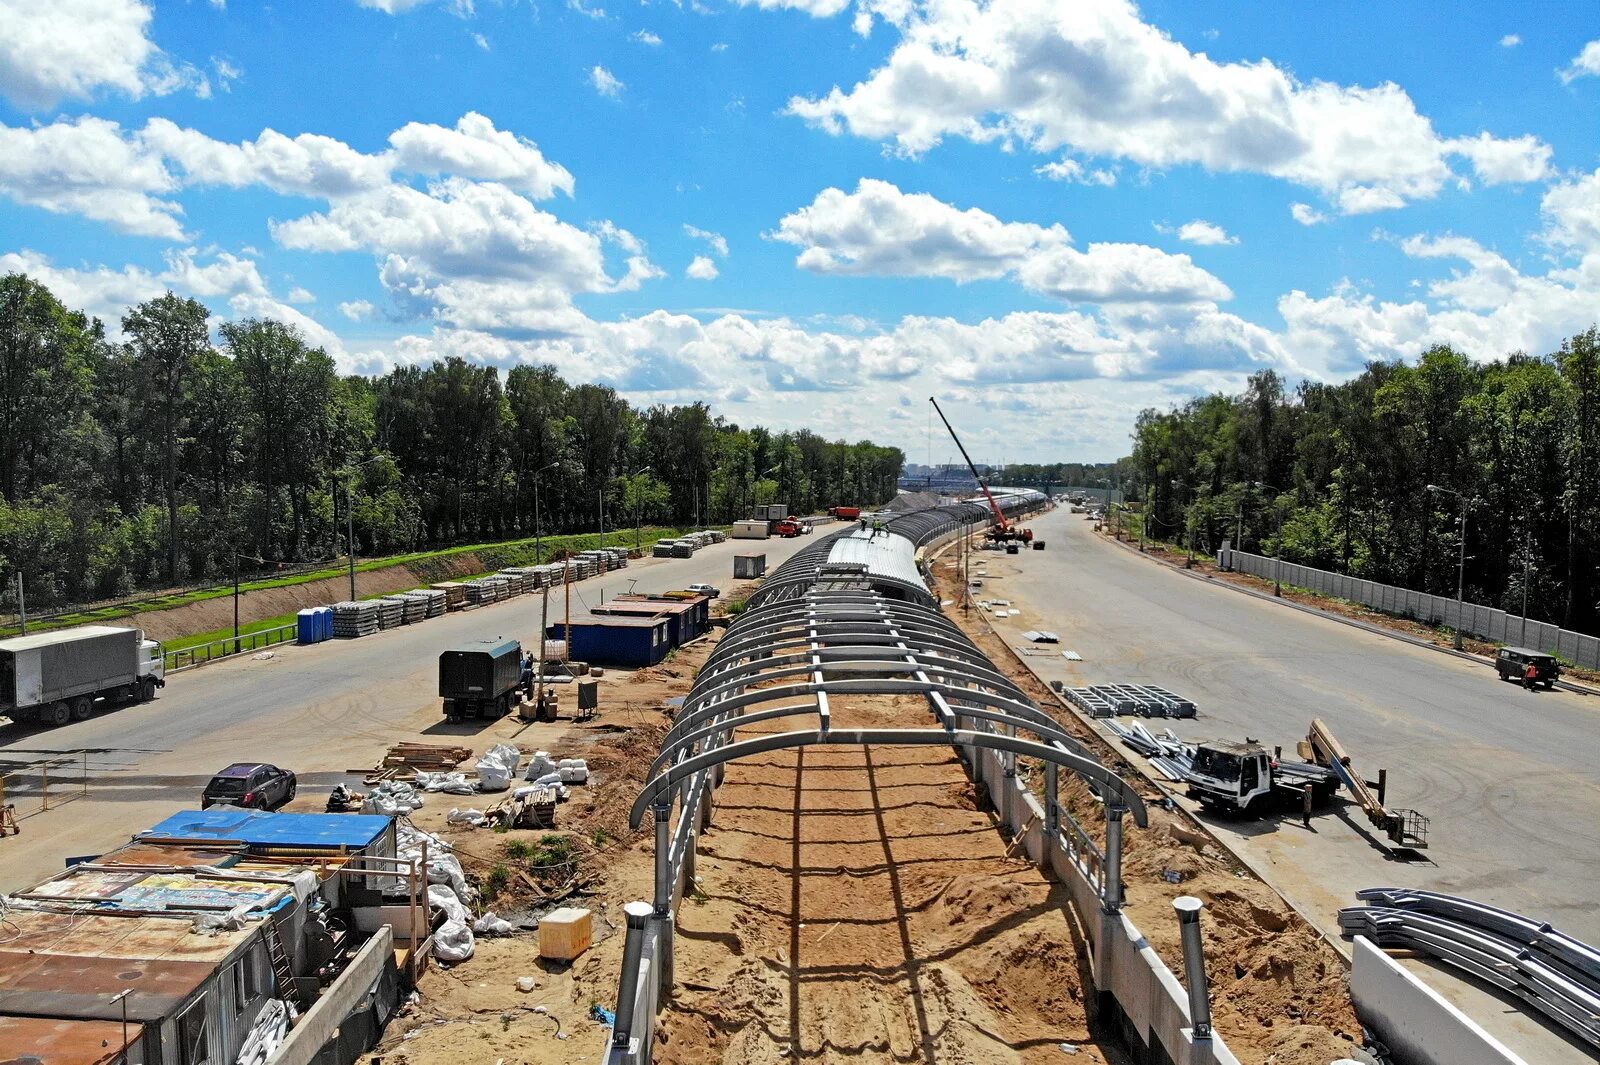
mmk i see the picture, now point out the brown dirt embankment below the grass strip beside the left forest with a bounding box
[132,552,488,640]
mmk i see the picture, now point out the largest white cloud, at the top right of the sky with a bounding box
[789,0,1555,214]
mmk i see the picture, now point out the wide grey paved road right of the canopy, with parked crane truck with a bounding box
[974,507,1600,1062]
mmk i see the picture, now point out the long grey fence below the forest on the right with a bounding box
[1218,547,1600,670]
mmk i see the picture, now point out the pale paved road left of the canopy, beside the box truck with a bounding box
[0,526,806,892]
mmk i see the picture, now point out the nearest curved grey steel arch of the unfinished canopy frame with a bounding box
[627,729,1149,828]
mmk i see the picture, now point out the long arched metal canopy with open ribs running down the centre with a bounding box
[608,493,1147,1065]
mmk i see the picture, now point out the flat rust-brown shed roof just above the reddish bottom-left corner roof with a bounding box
[0,943,216,1023]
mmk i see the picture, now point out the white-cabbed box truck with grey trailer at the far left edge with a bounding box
[0,625,166,724]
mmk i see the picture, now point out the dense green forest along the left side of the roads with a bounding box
[0,273,904,608]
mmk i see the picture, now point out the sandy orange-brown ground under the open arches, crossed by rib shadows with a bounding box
[656,687,1125,1065]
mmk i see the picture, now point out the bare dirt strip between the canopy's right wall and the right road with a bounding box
[934,546,1362,1065]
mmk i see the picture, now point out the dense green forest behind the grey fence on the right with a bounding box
[1133,328,1600,632]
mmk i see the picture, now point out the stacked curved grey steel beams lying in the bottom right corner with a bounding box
[1339,888,1600,1047]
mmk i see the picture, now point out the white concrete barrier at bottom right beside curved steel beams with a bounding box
[1350,935,1528,1065]
